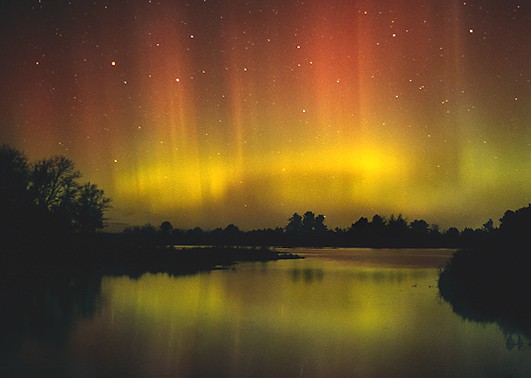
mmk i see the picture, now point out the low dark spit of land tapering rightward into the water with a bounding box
[0,235,302,277]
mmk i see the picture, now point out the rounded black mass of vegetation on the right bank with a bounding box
[439,205,531,338]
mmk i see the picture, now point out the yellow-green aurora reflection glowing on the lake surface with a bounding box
[79,260,529,377]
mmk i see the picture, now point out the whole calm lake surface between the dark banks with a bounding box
[0,249,531,377]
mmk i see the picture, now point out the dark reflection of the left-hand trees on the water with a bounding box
[0,273,101,376]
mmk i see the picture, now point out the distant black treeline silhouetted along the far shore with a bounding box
[123,211,510,248]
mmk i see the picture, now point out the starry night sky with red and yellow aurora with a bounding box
[0,0,531,230]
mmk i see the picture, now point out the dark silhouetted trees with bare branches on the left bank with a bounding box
[0,145,110,244]
